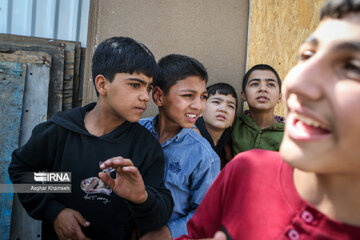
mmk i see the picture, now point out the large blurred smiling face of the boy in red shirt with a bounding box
[280,14,360,174]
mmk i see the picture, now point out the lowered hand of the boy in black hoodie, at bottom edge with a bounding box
[54,208,90,240]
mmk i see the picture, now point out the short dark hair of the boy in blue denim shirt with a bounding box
[154,54,208,94]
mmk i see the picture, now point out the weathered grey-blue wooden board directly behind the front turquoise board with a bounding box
[0,51,51,240]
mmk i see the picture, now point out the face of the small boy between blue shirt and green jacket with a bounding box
[203,93,236,130]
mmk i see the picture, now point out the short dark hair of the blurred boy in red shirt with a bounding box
[320,0,360,20]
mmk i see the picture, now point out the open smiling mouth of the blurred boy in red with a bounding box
[286,113,331,140]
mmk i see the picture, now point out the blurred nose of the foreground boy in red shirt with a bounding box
[283,56,331,101]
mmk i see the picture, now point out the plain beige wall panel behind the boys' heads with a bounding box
[83,0,249,116]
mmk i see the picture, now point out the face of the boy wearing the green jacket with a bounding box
[241,70,281,111]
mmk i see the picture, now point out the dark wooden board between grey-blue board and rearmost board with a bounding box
[0,40,64,118]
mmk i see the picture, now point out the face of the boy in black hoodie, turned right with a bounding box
[100,73,152,122]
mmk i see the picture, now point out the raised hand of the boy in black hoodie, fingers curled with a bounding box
[99,157,148,204]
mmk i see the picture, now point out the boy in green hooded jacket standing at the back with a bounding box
[231,64,284,155]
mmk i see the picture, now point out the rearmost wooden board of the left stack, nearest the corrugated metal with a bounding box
[0,34,81,110]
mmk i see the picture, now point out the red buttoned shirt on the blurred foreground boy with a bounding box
[178,149,360,240]
